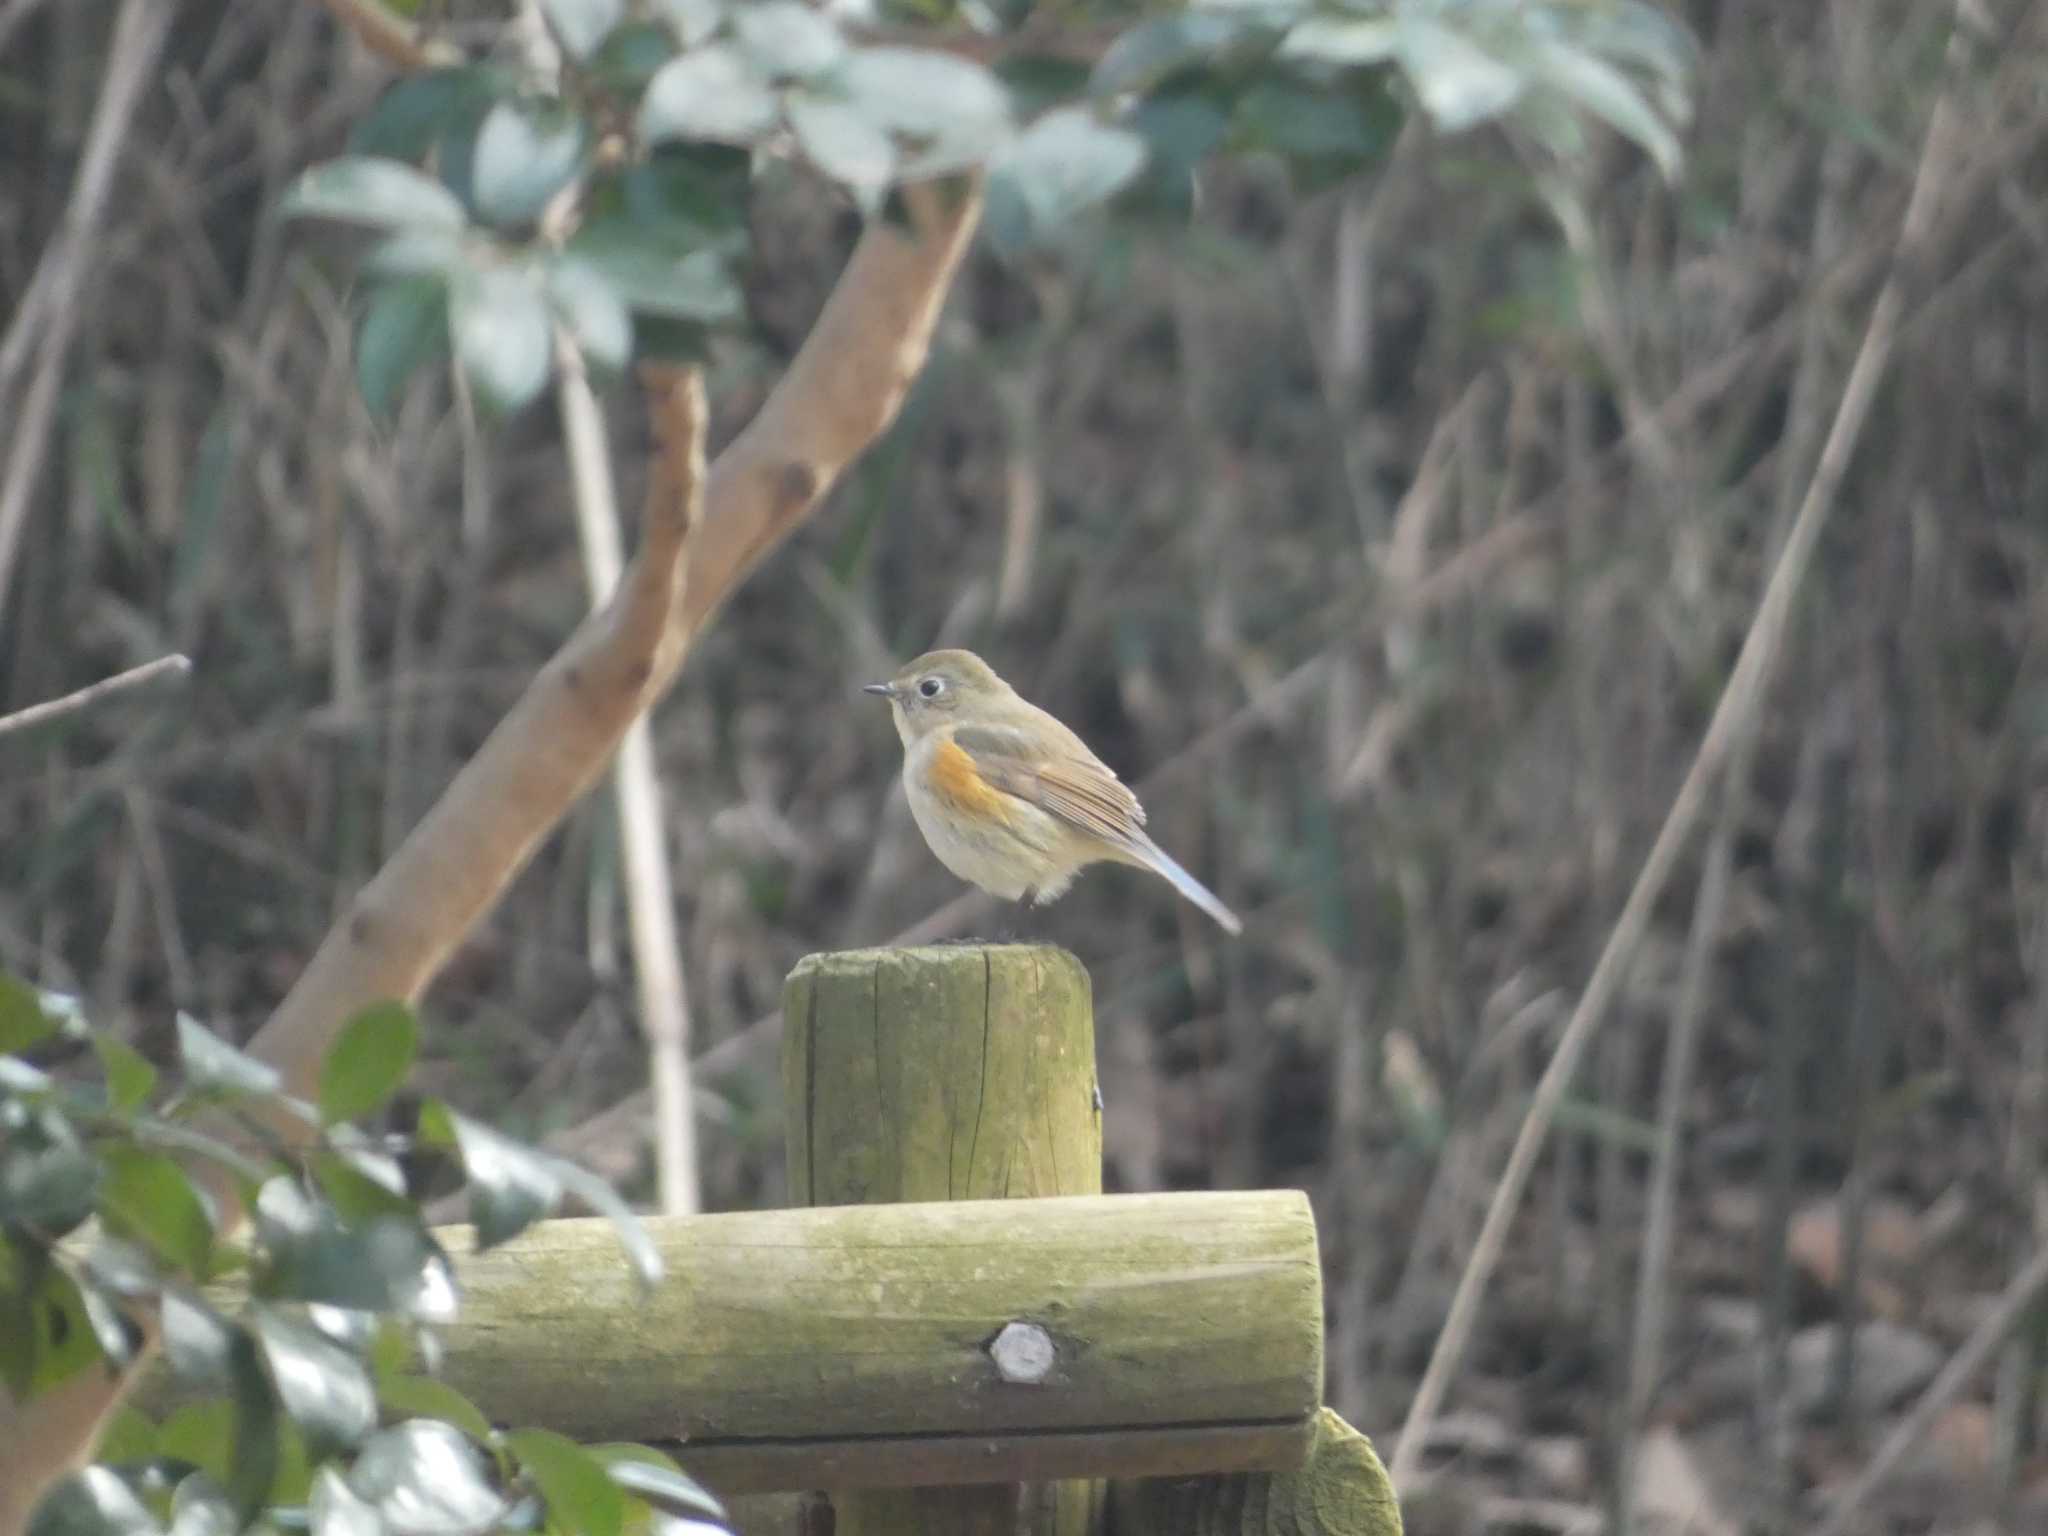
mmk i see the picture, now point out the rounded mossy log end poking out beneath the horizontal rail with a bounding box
[1110,1409,1401,1536]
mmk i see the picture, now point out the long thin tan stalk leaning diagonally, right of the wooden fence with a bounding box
[1389,0,1968,1487]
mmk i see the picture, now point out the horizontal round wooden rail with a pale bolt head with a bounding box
[442,1190,1323,1493]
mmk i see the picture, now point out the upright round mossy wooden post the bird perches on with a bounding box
[782,944,1102,1536]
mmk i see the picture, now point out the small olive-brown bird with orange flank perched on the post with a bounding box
[866,651,1243,934]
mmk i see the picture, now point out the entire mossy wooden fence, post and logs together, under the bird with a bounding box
[164,946,1401,1536]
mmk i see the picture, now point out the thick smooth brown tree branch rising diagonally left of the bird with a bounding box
[0,182,981,1536]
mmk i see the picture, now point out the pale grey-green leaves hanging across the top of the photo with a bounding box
[283,0,1692,414]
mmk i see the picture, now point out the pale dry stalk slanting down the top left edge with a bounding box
[0,0,174,630]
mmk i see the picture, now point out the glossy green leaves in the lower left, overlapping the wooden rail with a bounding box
[0,978,723,1536]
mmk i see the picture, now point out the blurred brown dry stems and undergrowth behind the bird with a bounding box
[0,0,2048,1532]
